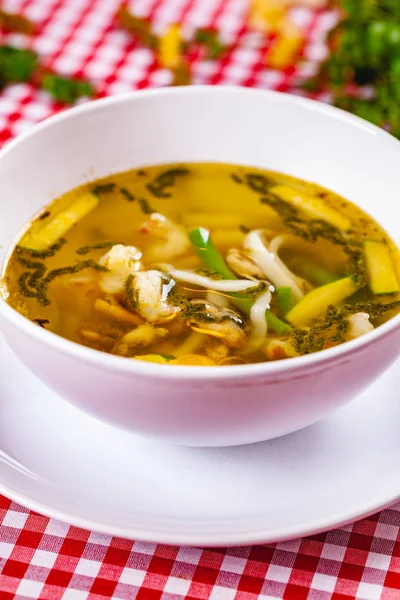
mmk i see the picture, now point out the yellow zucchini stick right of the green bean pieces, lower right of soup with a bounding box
[285,276,357,327]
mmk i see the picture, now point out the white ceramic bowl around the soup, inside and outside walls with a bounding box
[0,87,400,446]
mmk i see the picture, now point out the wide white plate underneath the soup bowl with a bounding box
[0,341,400,546]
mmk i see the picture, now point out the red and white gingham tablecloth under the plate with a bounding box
[0,0,400,600]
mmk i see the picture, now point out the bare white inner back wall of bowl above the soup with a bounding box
[0,87,400,264]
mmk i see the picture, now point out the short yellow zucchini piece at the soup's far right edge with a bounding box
[364,240,400,295]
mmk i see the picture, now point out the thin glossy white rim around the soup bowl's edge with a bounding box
[0,85,400,380]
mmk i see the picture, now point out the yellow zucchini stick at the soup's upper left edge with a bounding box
[21,192,99,251]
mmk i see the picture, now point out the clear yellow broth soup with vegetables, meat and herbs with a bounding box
[2,164,400,366]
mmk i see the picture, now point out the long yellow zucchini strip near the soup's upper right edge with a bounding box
[270,185,351,231]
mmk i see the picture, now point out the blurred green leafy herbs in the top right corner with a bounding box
[306,0,400,138]
